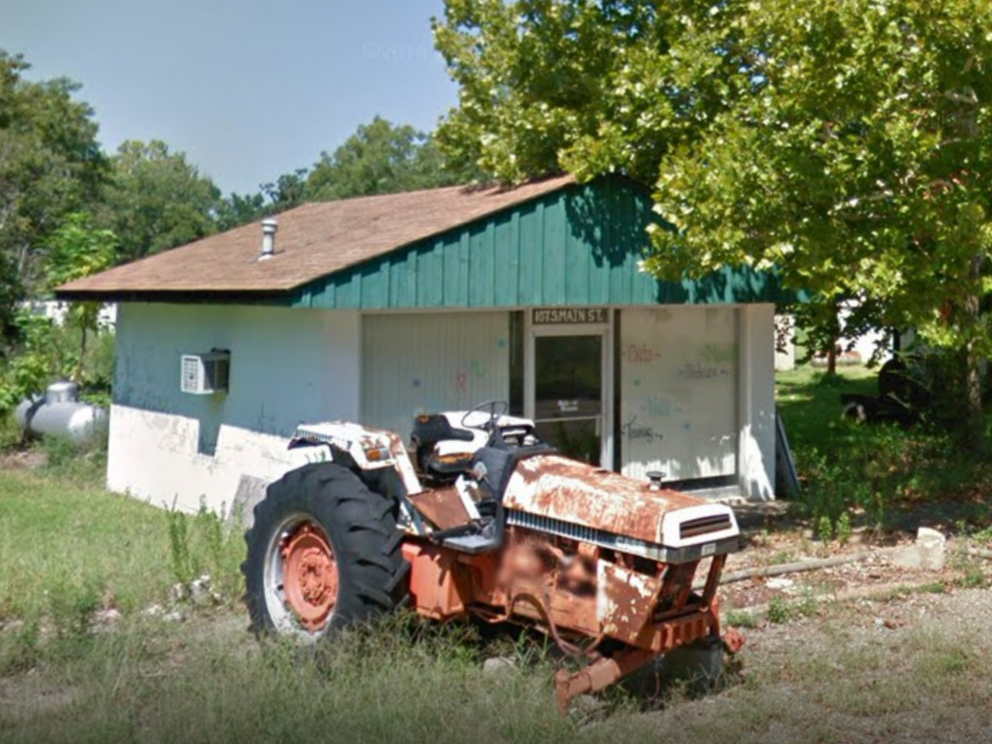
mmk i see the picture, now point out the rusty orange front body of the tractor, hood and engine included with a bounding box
[404,453,738,655]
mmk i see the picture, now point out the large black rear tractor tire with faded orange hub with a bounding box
[241,462,410,641]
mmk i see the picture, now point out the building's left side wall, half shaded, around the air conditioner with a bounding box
[107,304,361,510]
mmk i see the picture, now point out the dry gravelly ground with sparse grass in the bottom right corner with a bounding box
[647,589,992,743]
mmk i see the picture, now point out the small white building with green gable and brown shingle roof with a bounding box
[58,176,796,509]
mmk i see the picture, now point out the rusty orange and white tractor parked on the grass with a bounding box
[242,401,739,712]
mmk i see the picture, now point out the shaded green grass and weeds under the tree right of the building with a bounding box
[776,367,992,540]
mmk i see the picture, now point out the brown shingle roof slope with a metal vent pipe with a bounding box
[56,176,574,298]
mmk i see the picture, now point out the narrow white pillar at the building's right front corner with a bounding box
[737,304,775,500]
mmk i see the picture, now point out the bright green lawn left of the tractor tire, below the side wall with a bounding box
[0,463,243,676]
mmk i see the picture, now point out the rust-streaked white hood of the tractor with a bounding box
[503,455,739,556]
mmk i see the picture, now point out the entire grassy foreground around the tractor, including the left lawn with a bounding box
[0,438,992,744]
